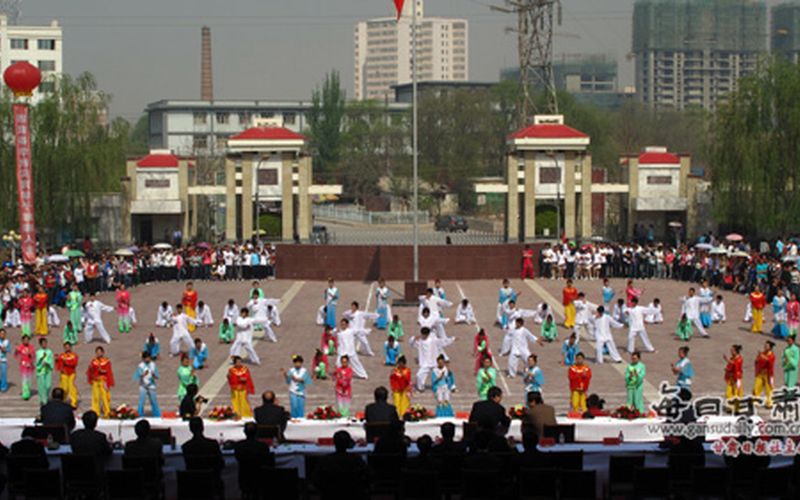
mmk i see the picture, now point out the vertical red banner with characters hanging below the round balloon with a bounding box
[14,104,36,264]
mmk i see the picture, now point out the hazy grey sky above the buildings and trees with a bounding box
[21,0,634,121]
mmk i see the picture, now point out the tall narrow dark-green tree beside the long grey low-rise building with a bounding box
[306,70,345,177]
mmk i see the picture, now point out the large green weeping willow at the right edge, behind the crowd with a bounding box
[710,59,800,235]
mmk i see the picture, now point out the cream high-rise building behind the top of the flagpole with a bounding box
[354,0,469,100]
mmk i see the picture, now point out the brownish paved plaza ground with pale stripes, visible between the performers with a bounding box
[0,279,785,417]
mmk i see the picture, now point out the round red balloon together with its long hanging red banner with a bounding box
[3,61,42,264]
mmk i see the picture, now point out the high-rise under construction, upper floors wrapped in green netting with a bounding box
[633,0,767,111]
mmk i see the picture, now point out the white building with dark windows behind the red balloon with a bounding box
[0,14,64,102]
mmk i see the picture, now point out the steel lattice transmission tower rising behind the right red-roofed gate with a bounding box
[492,0,561,127]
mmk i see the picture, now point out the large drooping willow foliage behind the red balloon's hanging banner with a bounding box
[0,73,130,243]
